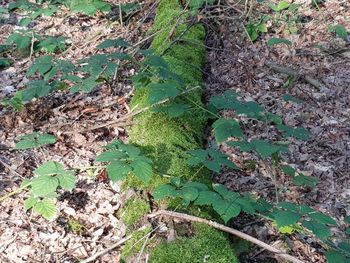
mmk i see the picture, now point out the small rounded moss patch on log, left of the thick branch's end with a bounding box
[119,197,150,227]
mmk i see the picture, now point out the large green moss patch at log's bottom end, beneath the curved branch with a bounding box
[150,224,237,263]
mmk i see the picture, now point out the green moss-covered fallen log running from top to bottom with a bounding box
[123,0,237,263]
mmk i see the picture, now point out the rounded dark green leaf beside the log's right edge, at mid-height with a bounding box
[212,119,243,142]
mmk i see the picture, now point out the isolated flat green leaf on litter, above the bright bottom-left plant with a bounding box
[15,132,56,150]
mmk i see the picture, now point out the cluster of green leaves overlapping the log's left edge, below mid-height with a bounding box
[96,140,153,183]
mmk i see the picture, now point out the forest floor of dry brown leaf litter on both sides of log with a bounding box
[0,1,350,262]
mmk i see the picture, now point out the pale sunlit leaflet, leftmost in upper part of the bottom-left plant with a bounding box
[31,175,59,196]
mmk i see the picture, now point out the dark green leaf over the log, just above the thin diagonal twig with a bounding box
[148,82,180,104]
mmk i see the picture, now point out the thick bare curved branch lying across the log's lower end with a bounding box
[148,210,304,263]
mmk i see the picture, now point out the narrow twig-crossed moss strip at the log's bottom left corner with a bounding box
[121,227,152,262]
